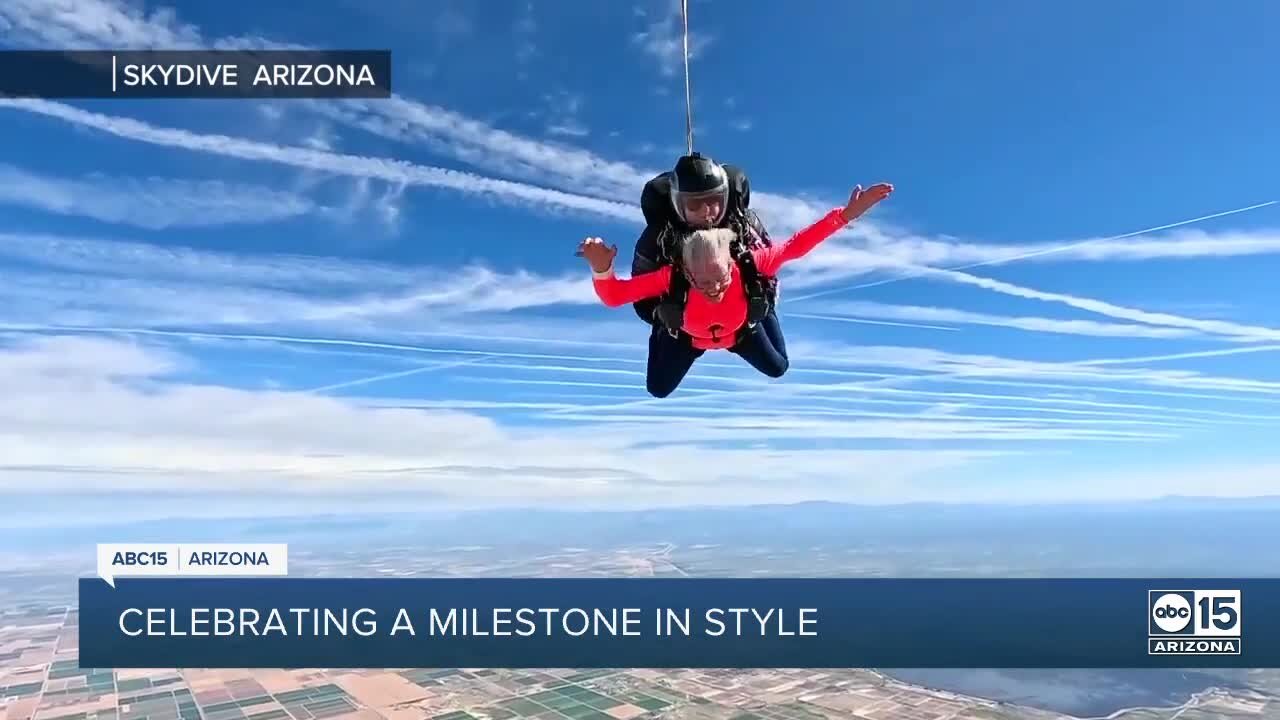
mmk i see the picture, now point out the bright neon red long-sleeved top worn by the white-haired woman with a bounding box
[591,208,847,350]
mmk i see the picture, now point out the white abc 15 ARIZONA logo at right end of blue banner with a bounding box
[1147,591,1242,655]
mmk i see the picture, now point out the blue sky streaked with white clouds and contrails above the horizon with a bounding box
[0,0,1280,511]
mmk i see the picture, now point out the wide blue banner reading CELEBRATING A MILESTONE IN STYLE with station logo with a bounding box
[79,578,1280,667]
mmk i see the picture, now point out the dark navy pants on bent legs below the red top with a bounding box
[645,311,791,397]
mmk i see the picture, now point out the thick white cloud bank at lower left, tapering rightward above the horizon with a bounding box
[0,338,1008,503]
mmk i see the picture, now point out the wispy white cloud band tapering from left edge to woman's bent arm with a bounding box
[0,226,604,334]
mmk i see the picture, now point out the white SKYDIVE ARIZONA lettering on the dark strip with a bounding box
[122,63,378,87]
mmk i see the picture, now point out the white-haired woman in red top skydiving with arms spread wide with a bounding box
[577,178,893,397]
